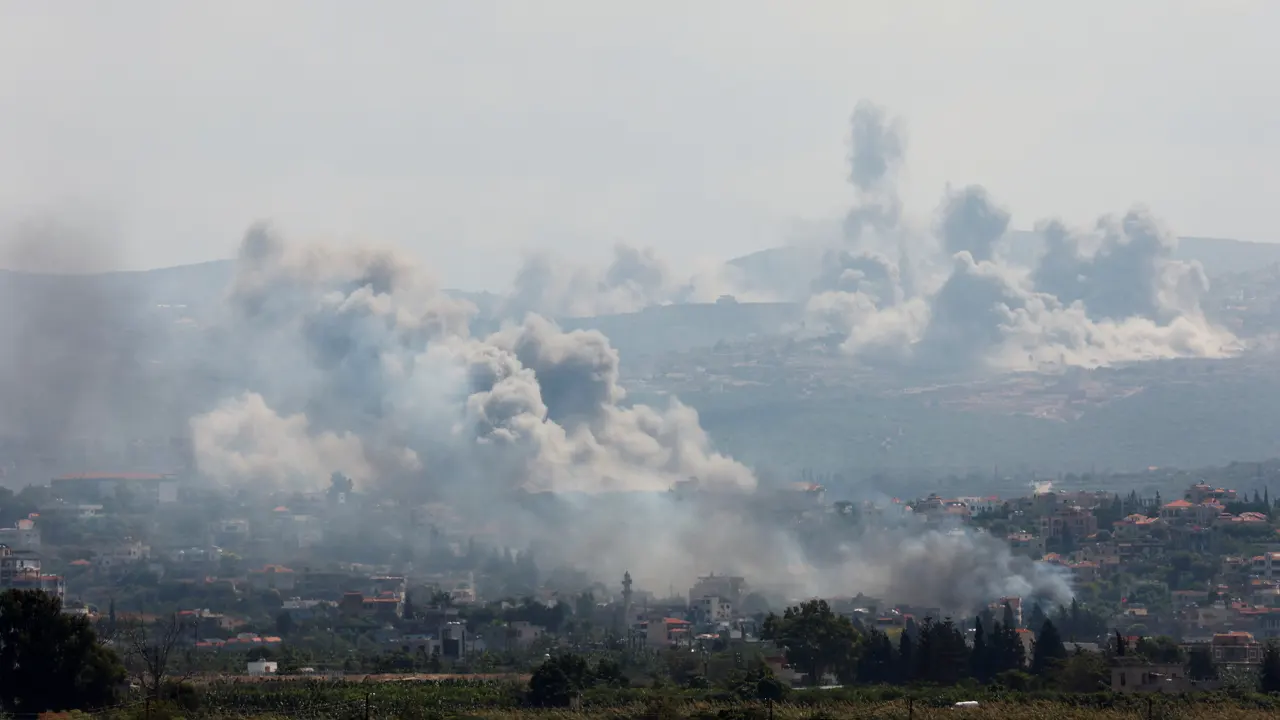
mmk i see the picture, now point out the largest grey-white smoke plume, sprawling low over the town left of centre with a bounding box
[180,225,1061,607]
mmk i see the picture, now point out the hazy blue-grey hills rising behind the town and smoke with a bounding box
[0,233,1280,482]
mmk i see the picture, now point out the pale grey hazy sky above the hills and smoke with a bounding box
[0,0,1280,288]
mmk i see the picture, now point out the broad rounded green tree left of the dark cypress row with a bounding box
[760,600,858,684]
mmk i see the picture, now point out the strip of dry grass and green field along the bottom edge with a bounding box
[49,680,1280,720]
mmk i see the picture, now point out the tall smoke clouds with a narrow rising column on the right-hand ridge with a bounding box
[808,102,1238,370]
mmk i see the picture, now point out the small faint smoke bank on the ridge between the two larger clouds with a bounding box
[502,243,746,318]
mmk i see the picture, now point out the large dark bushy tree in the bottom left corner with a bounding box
[0,591,124,715]
